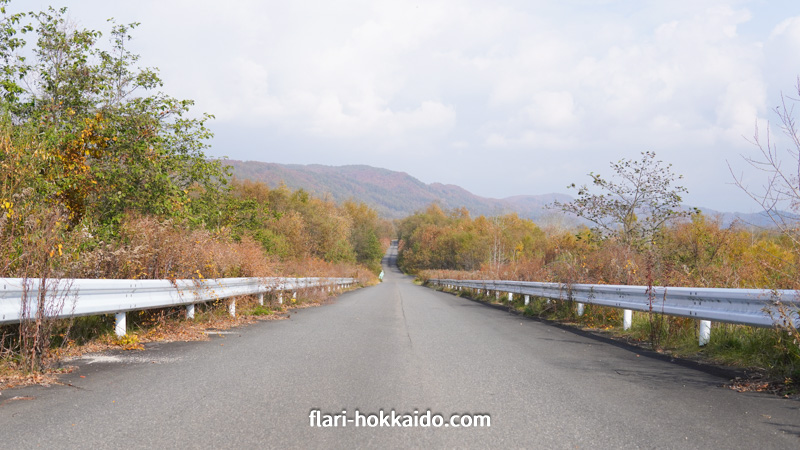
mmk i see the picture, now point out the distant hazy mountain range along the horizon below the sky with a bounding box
[225,160,772,227]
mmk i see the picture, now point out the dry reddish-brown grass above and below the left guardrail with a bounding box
[0,207,377,384]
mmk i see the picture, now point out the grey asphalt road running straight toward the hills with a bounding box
[0,248,800,448]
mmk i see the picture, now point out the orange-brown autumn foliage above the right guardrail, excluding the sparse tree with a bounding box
[398,185,800,289]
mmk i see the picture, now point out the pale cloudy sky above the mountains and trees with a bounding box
[18,0,800,211]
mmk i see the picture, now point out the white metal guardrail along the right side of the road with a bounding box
[428,279,800,345]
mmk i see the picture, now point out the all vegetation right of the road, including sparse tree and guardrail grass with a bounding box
[397,152,800,390]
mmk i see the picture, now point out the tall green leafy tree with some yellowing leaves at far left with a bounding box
[0,7,227,226]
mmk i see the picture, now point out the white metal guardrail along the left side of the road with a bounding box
[0,278,355,336]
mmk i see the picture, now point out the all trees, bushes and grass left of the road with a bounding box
[0,0,393,377]
